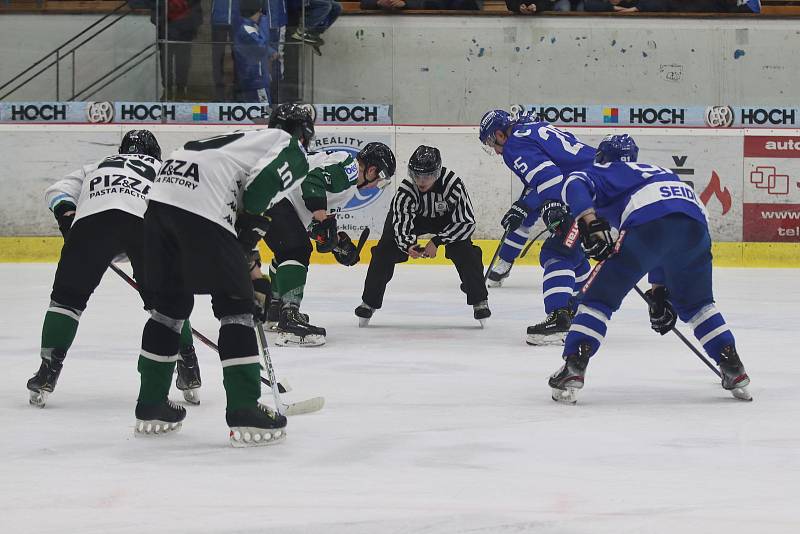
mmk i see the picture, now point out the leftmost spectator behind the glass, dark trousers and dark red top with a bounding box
[149,0,203,101]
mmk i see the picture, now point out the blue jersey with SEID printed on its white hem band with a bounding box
[562,161,707,230]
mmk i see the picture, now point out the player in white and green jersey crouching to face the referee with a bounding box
[264,136,396,346]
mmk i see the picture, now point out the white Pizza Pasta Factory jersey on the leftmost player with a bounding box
[45,154,161,221]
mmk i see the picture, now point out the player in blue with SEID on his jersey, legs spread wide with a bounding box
[549,135,752,403]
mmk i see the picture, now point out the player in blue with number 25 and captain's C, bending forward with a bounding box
[479,109,595,345]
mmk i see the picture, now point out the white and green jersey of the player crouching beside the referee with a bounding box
[289,151,358,227]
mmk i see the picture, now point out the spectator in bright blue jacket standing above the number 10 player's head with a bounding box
[233,0,278,104]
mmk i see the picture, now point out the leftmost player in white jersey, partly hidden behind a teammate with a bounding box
[27,134,200,408]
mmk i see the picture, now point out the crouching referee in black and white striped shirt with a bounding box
[355,145,492,326]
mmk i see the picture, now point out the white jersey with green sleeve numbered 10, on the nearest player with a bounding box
[150,128,308,234]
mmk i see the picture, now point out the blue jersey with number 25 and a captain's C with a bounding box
[503,120,595,214]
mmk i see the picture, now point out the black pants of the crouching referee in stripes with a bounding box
[361,212,489,309]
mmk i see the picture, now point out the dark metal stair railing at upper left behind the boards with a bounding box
[0,2,134,101]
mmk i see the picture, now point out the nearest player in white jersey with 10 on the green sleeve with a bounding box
[135,110,313,447]
